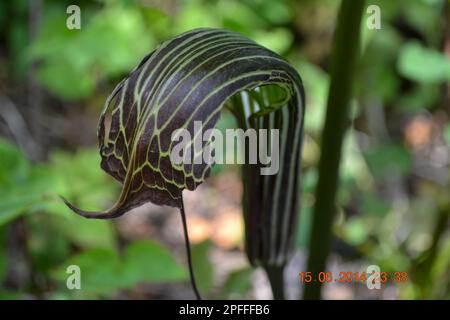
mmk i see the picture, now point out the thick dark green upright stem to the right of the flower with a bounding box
[304,0,365,299]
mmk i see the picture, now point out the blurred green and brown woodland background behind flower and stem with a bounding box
[0,0,450,299]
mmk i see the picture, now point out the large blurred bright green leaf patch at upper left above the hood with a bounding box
[28,2,154,100]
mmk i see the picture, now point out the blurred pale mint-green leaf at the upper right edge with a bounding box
[398,42,450,83]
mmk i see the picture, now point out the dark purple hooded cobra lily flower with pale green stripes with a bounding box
[65,29,304,297]
